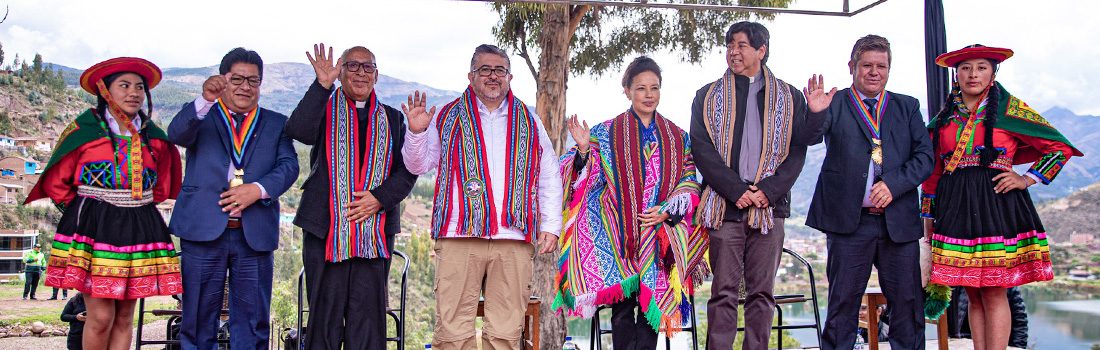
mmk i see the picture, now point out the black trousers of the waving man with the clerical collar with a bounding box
[301,232,394,350]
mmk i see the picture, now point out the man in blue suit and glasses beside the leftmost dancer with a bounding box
[168,47,298,350]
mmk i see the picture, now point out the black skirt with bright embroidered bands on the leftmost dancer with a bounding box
[46,192,183,299]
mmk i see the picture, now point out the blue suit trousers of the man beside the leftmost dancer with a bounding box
[179,229,275,350]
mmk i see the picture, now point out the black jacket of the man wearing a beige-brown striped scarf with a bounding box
[689,75,816,221]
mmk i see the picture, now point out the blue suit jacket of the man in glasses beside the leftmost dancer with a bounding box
[168,102,298,251]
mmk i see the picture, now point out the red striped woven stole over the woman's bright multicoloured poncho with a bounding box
[611,110,684,260]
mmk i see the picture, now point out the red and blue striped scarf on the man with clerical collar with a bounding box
[325,88,393,262]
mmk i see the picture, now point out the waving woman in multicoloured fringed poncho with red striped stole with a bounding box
[554,56,706,349]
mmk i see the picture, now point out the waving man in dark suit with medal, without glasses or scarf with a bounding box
[805,35,933,350]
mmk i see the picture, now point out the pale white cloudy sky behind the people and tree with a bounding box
[0,0,1100,129]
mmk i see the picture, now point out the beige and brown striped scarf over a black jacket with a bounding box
[695,67,794,234]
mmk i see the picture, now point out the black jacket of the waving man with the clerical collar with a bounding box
[286,80,417,239]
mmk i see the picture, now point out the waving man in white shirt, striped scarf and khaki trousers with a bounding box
[402,45,562,350]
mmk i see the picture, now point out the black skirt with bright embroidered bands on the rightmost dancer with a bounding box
[931,166,1054,287]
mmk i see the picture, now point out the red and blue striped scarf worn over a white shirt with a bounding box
[431,87,542,242]
